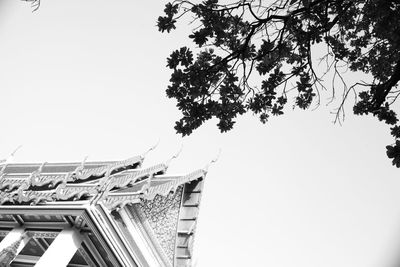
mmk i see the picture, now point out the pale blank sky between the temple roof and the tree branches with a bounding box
[0,0,400,267]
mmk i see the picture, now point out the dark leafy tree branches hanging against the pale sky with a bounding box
[157,0,400,167]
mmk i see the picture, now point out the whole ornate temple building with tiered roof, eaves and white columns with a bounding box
[0,152,207,267]
